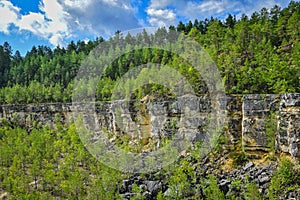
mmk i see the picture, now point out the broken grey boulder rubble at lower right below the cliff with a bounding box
[119,159,299,200]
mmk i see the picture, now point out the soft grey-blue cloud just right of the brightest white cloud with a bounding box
[61,0,141,36]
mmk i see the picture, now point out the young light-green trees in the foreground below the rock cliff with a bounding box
[0,122,300,200]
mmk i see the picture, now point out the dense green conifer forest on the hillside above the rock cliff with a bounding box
[0,1,300,104]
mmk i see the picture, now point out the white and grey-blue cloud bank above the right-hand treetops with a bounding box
[146,0,289,25]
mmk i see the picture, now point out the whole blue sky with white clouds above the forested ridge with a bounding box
[0,0,289,55]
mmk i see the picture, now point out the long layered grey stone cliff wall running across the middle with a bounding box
[0,94,300,159]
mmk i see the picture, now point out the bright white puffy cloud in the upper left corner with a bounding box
[0,0,71,45]
